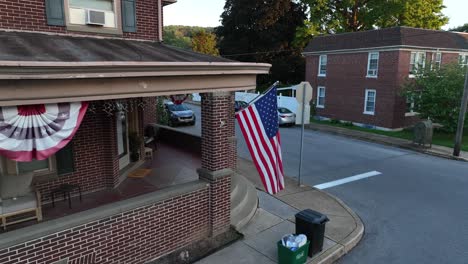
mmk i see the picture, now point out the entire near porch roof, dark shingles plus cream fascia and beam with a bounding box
[0,31,271,106]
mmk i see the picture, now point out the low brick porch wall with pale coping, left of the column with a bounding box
[0,189,209,264]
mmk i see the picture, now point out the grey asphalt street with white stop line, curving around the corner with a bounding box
[182,106,468,264]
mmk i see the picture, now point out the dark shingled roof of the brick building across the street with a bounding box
[304,27,468,53]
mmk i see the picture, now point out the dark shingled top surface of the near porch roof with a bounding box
[0,31,232,62]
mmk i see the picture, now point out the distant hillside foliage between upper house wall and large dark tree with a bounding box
[163,26,213,49]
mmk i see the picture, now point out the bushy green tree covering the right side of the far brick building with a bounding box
[402,64,467,132]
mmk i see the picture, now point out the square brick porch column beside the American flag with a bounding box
[199,92,237,236]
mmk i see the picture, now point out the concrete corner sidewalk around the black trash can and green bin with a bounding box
[197,158,364,264]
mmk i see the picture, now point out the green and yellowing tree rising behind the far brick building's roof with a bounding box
[298,0,448,42]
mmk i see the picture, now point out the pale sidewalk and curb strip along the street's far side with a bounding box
[306,125,468,162]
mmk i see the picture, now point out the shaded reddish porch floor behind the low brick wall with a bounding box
[0,142,201,233]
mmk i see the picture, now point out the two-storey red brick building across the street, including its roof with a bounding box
[303,27,468,130]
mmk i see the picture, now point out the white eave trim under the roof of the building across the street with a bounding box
[302,45,468,56]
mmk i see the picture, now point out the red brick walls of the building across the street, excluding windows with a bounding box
[306,51,458,128]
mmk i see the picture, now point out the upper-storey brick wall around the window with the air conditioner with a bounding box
[0,0,159,41]
